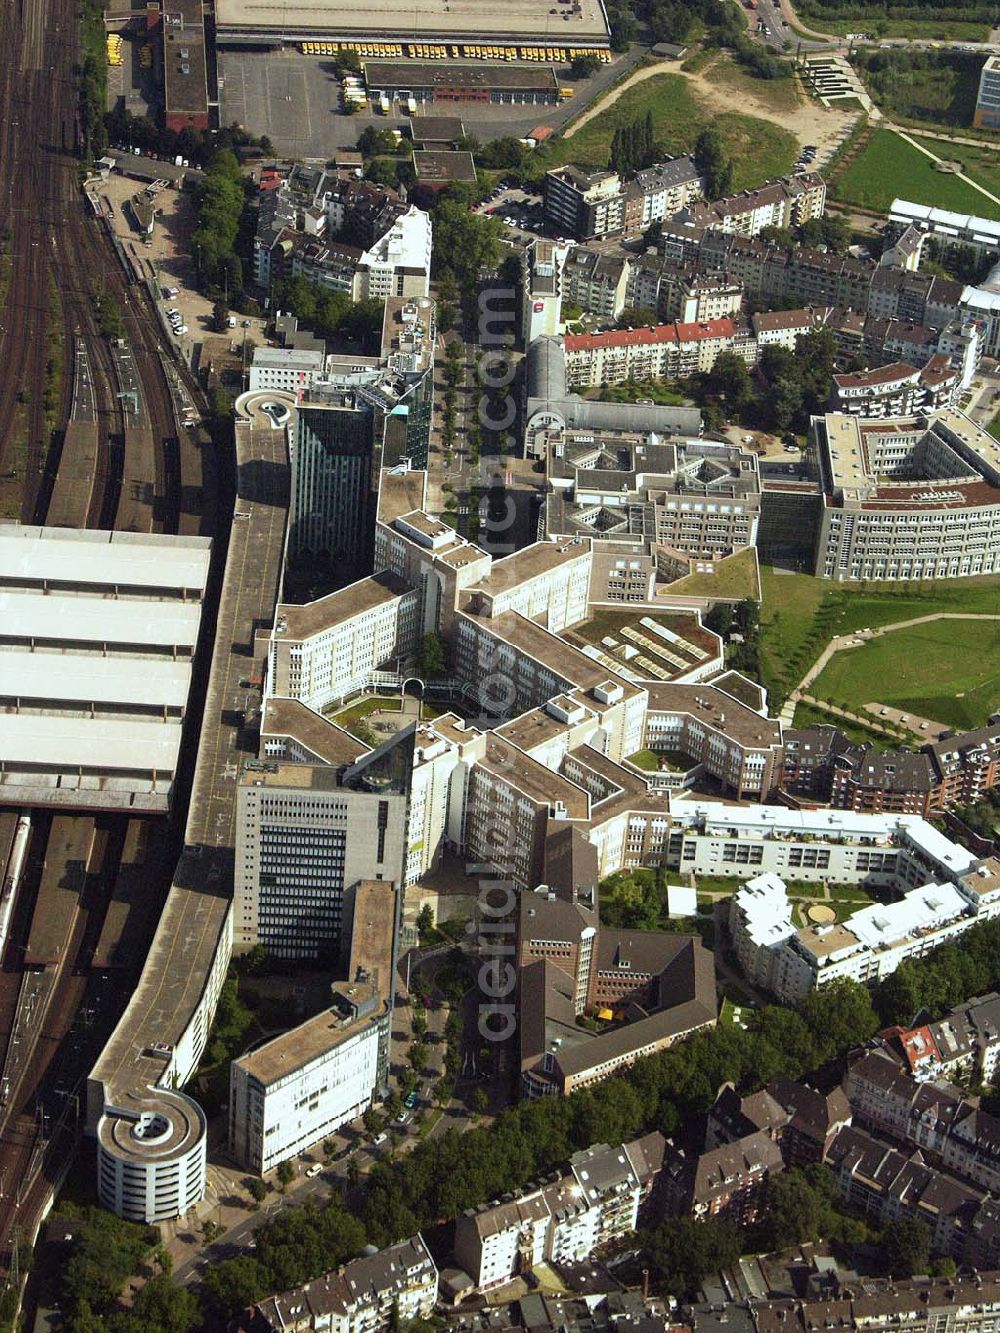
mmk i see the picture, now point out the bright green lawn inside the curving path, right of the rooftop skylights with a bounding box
[812,620,1000,729]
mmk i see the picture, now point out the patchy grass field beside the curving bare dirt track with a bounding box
[544,75,799,189]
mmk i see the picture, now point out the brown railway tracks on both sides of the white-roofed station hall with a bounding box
[0,0,225,1282]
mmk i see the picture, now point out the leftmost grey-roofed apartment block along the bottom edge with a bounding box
[253,1233,437,1333]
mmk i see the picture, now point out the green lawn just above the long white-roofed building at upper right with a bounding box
[833,129,1000,220]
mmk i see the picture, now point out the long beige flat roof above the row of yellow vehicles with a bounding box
[216,0,608,45]
